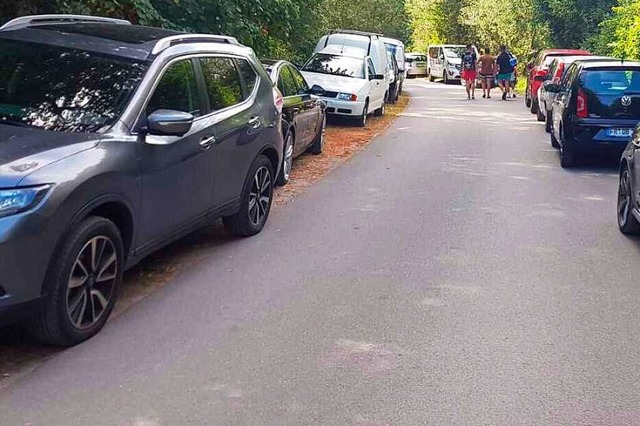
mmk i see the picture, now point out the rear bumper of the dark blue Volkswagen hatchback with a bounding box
[571,119,639,154]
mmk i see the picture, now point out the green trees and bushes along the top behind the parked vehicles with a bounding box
[0,0,640,64]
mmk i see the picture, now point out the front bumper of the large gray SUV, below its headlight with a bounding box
[0,211,57,324]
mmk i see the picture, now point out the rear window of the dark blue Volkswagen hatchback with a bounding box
[579,69,640,95]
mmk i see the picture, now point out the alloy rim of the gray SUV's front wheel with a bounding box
[67,236,118,330]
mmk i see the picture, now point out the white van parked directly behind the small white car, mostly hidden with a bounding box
[313,30,390,96]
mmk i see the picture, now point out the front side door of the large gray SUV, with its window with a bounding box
[137,59,214,248]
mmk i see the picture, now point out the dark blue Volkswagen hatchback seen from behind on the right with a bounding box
[546,61,640,168]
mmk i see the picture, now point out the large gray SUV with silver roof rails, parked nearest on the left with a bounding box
[0,15,283,345]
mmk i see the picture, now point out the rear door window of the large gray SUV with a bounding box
[200,58,244,111]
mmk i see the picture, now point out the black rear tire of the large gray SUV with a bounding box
[222,155,274,237]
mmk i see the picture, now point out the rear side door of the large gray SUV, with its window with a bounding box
[199,55,271,211]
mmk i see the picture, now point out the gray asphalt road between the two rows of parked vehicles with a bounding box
[0,81,640,426]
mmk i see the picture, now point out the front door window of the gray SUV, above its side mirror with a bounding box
[146,59,202,117]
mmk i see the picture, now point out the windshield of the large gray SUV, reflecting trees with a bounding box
[0,39,147,132]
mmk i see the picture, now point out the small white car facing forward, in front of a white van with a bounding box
[302,46,388,127]
